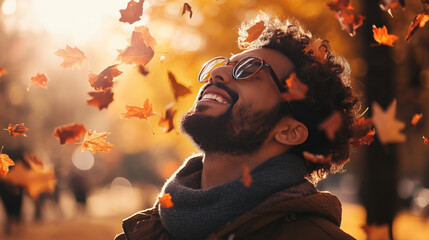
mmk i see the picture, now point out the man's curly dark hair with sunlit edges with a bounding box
[238,13,358,182]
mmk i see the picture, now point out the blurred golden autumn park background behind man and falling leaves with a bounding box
[0,0,429,239]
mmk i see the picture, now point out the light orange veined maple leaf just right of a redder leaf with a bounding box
[81,130,113,154]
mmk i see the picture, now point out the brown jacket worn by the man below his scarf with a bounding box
[115,183,354,240]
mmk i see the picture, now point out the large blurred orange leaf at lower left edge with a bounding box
[4,161,56,199]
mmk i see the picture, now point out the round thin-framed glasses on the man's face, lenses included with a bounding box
[198,57,286,92]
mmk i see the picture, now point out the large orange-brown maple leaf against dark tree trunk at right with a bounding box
[372,100,407,144]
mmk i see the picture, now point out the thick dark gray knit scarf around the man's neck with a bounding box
[159,154,306,240]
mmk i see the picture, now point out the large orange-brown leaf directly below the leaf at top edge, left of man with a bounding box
[117,28,155,66]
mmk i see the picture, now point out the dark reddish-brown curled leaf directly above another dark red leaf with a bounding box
[88,64,122,91]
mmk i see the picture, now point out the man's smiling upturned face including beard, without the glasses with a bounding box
[182,48,294,154]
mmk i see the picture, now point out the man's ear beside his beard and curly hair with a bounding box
[274,117,308,146]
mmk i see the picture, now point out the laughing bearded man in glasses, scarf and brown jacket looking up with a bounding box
[116,14,356,240]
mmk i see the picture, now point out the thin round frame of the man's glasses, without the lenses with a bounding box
[198,56,286,92]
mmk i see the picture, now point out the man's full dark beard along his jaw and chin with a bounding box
[181,100,284,155]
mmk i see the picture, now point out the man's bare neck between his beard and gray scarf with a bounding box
[201,143,285,189]
